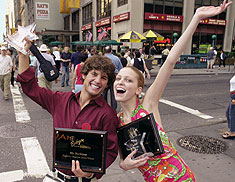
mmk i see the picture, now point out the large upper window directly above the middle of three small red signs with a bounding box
[97,0,112,20]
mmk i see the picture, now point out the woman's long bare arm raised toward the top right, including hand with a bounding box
[143,0,232,112]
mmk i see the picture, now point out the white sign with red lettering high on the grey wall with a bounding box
[35,2,50,20]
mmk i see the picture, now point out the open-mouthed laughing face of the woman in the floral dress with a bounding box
[113,67,143,102]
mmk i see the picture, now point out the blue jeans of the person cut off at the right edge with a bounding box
[226,94,235,132]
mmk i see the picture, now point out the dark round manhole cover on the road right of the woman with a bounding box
[177,135,227,154]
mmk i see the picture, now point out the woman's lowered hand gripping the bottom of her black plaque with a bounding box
[119,150,149,170]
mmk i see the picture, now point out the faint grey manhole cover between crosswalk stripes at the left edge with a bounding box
[0,124,35,138]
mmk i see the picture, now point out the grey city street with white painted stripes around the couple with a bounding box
[0,70,235,182]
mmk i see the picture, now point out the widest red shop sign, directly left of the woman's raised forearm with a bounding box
[144,13,183,22]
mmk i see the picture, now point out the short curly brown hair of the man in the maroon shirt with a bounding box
[80,55,115,85]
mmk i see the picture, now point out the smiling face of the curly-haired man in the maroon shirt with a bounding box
[82,70,108,98]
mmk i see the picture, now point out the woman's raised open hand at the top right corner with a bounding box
[195,0,233,19]
